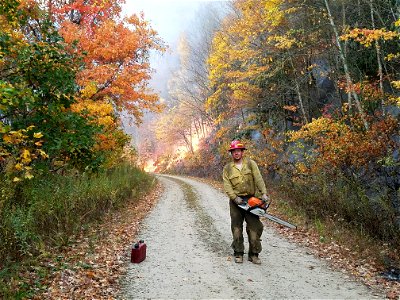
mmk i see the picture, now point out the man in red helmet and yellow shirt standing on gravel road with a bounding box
[223,140,269,264]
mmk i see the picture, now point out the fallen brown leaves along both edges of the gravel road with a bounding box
[25,180,400,299]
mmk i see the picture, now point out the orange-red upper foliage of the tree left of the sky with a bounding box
[48,0,165,123]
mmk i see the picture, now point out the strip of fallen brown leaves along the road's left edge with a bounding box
[32,184,162,299]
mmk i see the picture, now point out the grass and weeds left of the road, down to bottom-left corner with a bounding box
[0,164,154,299]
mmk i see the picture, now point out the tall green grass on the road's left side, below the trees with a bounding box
[0,165,154,267]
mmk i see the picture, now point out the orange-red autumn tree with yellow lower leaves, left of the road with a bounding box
[31,0,165,169]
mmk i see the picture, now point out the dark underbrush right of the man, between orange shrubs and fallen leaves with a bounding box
[272,174,400,264]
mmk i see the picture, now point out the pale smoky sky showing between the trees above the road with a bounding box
[123,0,228,162]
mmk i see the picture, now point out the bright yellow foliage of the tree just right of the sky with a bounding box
[207,0,300,122]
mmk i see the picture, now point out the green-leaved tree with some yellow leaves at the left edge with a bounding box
[0,1,101,179]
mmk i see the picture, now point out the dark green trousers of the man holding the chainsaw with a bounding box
[229,201,264,255]
